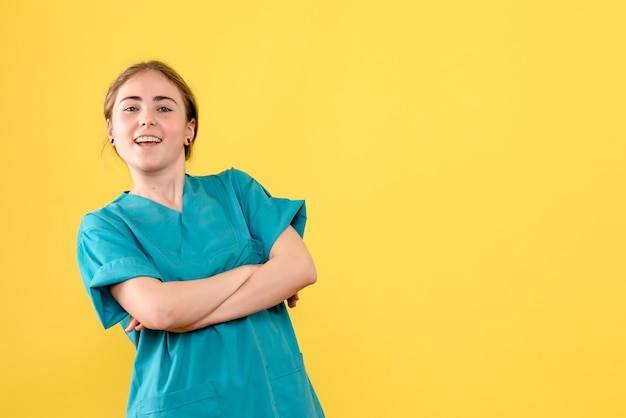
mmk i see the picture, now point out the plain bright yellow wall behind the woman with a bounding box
[0,0,626,418]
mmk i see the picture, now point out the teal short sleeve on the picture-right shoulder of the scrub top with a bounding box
[228,169,306,258]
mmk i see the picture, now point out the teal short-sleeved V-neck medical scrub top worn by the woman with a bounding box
[78,169,324,418]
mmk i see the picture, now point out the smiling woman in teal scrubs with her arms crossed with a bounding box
[77,61,324,418]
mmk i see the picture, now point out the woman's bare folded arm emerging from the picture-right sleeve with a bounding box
[168,226,317,332]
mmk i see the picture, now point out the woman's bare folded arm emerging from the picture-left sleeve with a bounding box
[110,265,259,330]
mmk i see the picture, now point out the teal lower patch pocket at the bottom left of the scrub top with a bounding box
[139,382,224,418]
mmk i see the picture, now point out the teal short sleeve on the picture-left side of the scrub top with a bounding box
[77,214,159,328]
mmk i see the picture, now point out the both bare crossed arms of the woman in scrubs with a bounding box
[110,226,317,332]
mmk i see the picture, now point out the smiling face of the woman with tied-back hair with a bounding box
[107,70,195,174]
